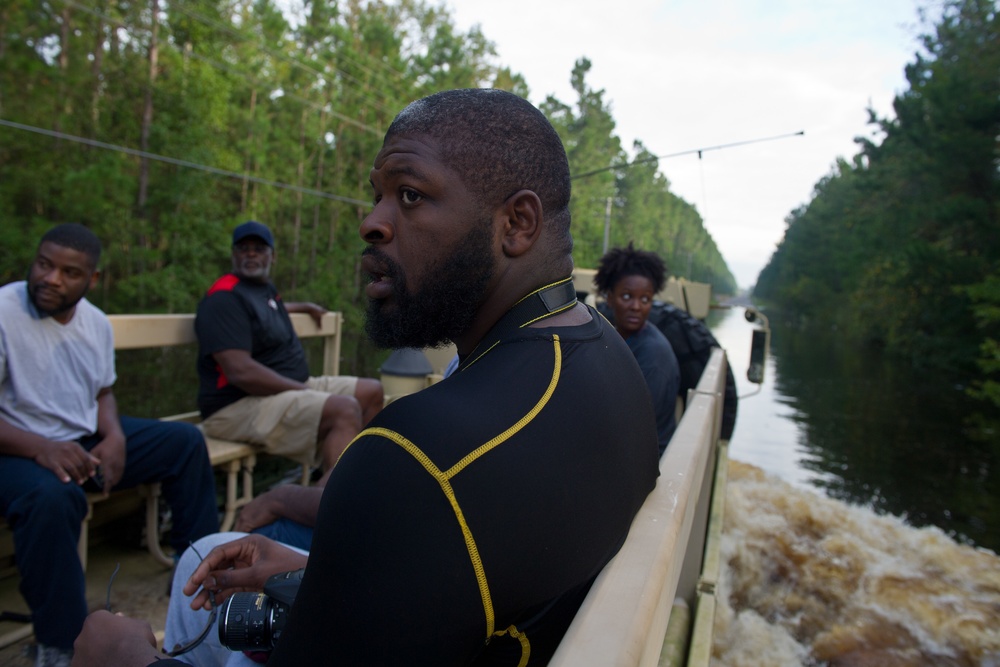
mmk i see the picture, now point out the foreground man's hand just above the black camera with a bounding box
[184,535,307,609]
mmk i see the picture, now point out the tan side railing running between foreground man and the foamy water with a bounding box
[549,349,726,667]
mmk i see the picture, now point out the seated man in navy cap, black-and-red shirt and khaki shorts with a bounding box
[195,220,383,494]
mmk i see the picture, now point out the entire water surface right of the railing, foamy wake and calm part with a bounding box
[709,308,1000,667]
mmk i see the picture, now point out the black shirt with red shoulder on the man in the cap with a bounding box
[194,273,309,418]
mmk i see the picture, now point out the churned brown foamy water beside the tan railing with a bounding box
[712,462,1000,667]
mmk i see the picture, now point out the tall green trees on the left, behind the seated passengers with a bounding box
[0,0,735,371]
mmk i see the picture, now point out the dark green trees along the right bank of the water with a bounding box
[754,0,1000,405]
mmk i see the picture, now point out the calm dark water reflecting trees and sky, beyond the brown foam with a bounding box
[709,308,1000,551]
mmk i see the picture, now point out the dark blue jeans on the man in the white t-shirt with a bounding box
[0,417,219,649]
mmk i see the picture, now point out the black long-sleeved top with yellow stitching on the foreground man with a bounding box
[268,311,658,667]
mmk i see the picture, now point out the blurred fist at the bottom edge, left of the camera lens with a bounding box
[73,609,162,667]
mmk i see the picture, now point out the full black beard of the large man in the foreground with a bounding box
[365,220,496,349]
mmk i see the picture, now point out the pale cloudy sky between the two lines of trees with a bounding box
[438,0,924,287]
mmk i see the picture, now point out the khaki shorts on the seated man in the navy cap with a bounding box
[202,375,358,465]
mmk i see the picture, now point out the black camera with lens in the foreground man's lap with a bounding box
[219,570,305,651]
